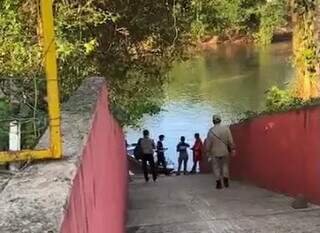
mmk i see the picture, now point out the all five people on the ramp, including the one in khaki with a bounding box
[136,115,235,189]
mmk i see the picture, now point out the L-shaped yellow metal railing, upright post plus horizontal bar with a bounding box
[0,0,62,163]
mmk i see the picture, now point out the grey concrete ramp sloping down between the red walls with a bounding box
[127,175,320,233]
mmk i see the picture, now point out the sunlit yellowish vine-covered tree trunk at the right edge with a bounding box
[293,0,320,100]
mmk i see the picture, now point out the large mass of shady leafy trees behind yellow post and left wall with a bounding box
[0,0,188,131]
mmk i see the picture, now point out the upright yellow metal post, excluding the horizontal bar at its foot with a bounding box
[40,0,62,158]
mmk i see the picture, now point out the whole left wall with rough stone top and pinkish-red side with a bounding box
[0,78,128,233]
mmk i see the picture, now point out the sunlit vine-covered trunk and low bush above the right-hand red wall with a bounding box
[255,0,320,119]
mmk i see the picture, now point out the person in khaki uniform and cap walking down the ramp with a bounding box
[205,115,235,189]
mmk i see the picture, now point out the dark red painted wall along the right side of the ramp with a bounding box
[231,107,320,204]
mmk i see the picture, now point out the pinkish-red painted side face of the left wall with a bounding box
[61,88,128,233]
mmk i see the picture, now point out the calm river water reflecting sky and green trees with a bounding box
[126,43,293,167]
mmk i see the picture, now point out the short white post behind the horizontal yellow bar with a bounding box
[9,121,21,171]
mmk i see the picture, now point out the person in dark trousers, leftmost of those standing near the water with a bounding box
[138,130,157,182]
